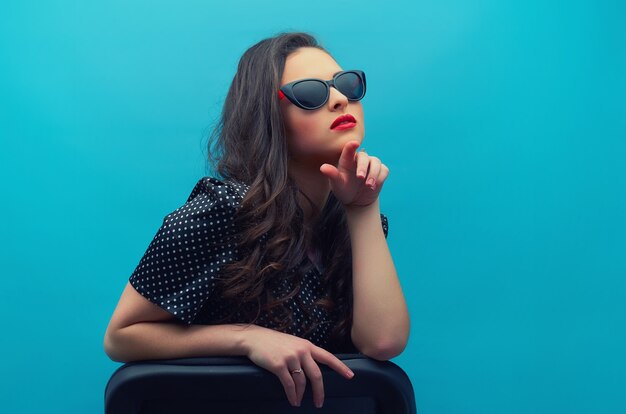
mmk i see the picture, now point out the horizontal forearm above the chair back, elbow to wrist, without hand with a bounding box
[105,322,255,362]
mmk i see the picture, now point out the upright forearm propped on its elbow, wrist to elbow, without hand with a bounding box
[346,199,410,359]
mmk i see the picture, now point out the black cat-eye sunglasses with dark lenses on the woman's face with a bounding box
[278,70,365,110]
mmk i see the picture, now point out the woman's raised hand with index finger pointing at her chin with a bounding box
[320,141,389,206]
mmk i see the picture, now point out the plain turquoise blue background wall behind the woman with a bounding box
[0,0,626,414]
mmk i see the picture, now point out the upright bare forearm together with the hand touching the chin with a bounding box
[320,139,410,360]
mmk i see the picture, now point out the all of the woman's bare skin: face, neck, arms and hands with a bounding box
[105,48,409,406]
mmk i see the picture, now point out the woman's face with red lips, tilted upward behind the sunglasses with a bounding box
[280,47,365,168]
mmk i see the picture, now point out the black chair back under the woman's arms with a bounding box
[104,354,417,414]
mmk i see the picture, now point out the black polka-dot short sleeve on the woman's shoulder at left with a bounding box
[129,177,238,325]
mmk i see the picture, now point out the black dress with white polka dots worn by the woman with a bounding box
[129,177,388,352]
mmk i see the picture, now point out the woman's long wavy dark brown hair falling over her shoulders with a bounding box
[202,32,352,352]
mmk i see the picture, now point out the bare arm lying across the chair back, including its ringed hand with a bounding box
[104,283,354,406]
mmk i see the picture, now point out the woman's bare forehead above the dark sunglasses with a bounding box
[281,47,342,85]
